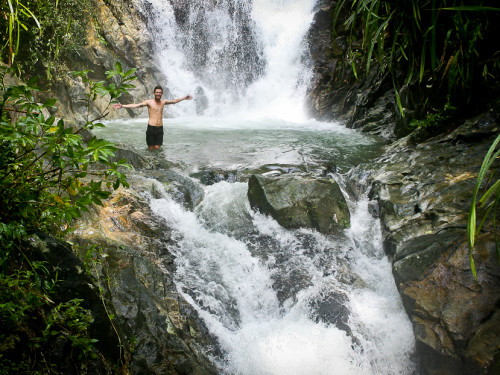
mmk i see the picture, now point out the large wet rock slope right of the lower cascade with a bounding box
[351,110,500,375]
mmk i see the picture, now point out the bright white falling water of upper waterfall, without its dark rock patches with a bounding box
[140,0,316,121]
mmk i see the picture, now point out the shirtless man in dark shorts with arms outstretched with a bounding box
[113,86,193,150]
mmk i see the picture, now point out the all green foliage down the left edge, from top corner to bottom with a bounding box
[0,0,141,374]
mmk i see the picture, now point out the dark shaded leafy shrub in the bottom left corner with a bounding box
[0,260,96,374]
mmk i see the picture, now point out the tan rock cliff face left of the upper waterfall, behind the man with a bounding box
[47,0,165,121]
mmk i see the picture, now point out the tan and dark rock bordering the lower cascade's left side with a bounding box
[69,189,217,375]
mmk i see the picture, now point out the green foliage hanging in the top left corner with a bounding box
[0,0,92,79]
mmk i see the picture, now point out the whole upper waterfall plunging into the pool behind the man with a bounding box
[139,0,316,120]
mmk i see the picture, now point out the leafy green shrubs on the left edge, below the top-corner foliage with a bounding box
[0,63,136,374]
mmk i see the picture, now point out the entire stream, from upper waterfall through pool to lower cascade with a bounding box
[98,0,416,375]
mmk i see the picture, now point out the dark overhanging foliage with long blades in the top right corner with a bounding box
[335,0,500,115]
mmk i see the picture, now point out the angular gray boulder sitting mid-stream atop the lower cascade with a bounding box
[248,175,350,234]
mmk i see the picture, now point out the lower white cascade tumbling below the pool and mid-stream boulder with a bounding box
[147,182,414,375]
